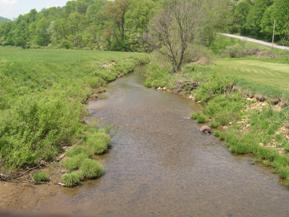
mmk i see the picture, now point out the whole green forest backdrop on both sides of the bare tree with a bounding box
[0,0,289,51]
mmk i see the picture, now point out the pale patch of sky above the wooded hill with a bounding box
[0,0,68,19]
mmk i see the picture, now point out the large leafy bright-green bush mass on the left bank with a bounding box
[0,93,82,169]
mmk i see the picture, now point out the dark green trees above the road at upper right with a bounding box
[231,0,289,45]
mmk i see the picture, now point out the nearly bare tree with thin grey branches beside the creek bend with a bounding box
[151,0,201,72]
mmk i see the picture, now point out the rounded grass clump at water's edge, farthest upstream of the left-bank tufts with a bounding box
[86,132,111,154]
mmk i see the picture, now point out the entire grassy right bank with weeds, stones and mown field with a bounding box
[145,41,289,185]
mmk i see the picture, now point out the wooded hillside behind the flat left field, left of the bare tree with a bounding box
[0,0,229,51]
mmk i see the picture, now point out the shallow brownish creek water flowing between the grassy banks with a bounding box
[0,71,289,217]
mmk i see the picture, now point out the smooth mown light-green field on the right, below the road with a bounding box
[213,59,289,98]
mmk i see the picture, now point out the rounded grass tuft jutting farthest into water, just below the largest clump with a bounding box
[80,159,104,179]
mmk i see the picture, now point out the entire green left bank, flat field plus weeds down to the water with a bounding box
[0,48,148,185]
